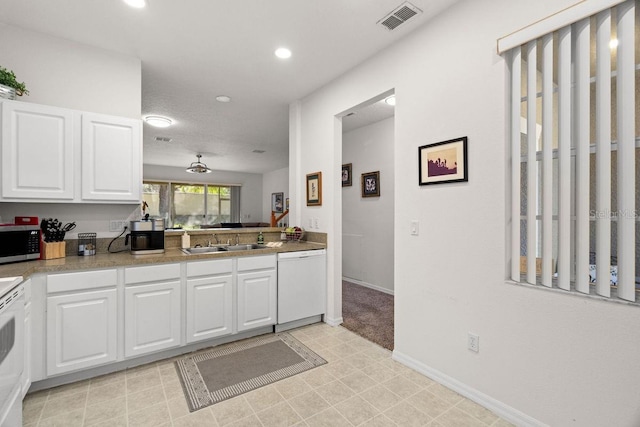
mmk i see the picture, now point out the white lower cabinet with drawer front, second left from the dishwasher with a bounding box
[185,259,233,343]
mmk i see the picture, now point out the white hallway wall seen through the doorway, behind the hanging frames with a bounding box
[342,117,395,294]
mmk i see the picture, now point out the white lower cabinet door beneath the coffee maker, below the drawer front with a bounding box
[124,280,180,357]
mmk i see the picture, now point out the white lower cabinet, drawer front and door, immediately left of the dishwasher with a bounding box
[237,255,278,332]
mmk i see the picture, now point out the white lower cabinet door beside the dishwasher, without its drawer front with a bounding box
[238,269,277,331]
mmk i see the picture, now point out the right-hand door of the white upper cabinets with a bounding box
[82,113,142,202]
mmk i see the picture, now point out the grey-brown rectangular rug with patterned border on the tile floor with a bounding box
[176,332,327,412]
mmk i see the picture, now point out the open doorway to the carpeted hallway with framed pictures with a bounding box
[342,91,395,350]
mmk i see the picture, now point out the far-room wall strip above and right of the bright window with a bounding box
[142,165,268,222]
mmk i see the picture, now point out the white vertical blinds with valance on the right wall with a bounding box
[499,0,640,301]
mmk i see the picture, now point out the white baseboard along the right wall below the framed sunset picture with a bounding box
[392,350,548,427]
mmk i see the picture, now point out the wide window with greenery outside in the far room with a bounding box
[142,182,240,228]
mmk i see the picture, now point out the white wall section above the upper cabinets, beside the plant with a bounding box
[0,23,142,119]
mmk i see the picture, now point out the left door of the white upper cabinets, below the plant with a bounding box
[0,101,76,201]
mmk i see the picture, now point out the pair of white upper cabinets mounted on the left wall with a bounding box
[0,101,142,203]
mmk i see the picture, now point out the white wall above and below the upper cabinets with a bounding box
[0,23,142,237]
